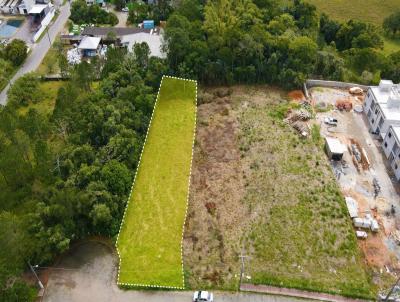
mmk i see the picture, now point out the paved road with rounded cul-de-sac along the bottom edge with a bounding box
[43,242,307,302]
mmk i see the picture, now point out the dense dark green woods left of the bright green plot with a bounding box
[0,44,165,301]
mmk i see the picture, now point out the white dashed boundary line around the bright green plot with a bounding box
[115,75,197,289]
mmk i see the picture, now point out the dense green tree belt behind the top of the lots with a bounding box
[164,0,393,88]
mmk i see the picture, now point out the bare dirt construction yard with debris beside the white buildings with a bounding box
[310,87,400,283]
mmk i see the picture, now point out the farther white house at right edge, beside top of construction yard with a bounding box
[364,80,400,139]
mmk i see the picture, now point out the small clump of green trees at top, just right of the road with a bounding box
[69,0,118,25]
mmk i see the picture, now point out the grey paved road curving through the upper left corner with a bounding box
[0,2,70,105]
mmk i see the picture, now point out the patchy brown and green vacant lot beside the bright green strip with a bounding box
[184,87,372,297]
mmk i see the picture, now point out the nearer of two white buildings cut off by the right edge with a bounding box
[382,126,400,180]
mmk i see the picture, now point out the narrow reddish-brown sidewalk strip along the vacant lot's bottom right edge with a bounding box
[240,284,365,302]
